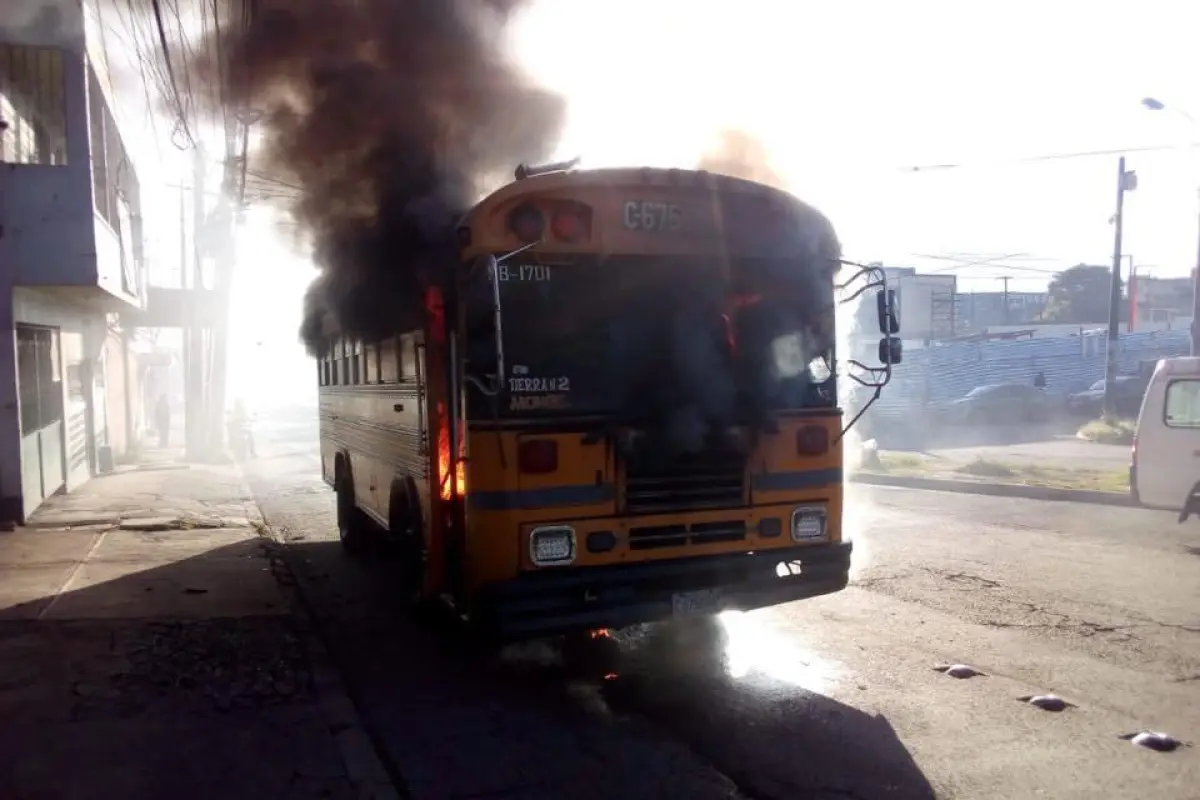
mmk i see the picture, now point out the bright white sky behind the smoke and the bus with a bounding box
[91,0,1200,396]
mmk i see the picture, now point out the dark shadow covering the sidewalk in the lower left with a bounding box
[0,530,354,800]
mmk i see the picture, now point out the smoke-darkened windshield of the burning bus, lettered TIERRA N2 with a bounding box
[468,257,835,417]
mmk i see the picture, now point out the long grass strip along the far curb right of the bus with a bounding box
[880,453,1129,494]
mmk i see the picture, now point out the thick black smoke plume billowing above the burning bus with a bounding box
[213,0,564,351]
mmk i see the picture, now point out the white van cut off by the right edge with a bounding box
[1129,357,1200,522]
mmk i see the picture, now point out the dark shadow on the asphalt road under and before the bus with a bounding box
[278,527,934,800]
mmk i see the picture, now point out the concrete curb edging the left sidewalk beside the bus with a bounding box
[236,467,402,800]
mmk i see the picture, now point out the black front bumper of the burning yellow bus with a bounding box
[475,542,852,639]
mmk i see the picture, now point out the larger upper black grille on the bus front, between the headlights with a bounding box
[625,452,745,513]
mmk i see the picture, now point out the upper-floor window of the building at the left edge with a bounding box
[0,44,67,167]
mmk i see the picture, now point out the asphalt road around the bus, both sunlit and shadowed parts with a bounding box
[246,423,1200,800]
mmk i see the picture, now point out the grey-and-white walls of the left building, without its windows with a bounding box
[0,0,145,519]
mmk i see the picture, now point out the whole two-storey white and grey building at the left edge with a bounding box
[0,0,145,523]
